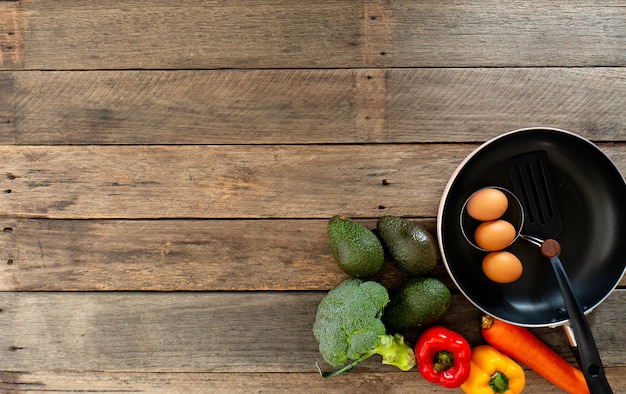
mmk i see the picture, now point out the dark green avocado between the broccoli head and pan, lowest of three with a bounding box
[383,278,452,329]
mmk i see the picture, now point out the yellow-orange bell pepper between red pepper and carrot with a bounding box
[461,345,526,394]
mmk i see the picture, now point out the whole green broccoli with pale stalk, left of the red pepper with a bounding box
[313,279,415,378]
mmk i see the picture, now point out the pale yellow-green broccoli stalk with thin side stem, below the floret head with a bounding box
[316,334,415,378]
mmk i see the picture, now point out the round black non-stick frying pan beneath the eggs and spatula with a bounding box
[437,129,626,326]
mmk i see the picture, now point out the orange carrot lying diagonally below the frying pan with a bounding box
[482,316,589,394]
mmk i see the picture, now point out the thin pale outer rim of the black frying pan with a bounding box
[437,126,626,327]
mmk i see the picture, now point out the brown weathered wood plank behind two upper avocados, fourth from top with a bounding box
[0,219,626,291]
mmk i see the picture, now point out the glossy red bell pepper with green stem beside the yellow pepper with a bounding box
[415,326,472,388]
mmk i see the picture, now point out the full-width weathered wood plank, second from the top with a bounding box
[0,68,626,145]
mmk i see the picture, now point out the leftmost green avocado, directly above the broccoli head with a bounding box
[328,215,385,279]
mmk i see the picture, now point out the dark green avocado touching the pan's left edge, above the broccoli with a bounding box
[376,216,439,276]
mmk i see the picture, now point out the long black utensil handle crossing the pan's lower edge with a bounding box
[550,256,613,394]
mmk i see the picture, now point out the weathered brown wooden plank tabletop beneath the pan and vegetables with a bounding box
[0,0,626,393]
